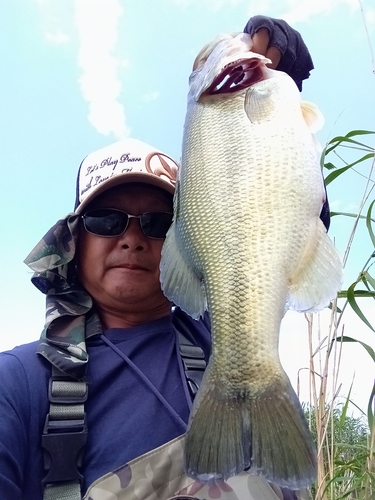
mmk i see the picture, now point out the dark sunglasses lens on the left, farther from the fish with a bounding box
[83,209,128,236]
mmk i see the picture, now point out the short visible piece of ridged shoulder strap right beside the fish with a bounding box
[176,328,207,399]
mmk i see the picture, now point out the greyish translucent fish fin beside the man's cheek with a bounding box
[160,223,207,319]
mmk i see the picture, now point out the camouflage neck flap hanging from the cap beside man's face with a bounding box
[24,214,102,378]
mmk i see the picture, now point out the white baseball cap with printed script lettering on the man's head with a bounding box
[74,138,178,213]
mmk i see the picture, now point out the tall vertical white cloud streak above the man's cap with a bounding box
[75,0,129,139]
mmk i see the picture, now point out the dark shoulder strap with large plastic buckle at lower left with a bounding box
[42,366,87,500]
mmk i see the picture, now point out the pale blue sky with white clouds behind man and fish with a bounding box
[0,0,375,412]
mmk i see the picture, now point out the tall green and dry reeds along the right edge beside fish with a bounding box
[306,130,375,500]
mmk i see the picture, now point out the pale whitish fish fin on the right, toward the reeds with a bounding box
[287,219,343,312]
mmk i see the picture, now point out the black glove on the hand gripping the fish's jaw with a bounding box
[244,16,314,91]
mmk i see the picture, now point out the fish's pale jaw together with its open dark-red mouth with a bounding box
[189,33,271,101]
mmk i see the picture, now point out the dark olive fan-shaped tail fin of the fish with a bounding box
[185,377,316,490]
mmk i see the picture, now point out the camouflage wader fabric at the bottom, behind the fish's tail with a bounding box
[84,436,309,500]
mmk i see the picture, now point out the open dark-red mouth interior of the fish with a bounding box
[205,57,264,95]
